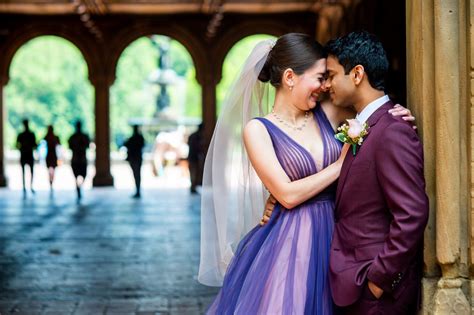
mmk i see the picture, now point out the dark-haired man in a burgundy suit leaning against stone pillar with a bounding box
[326,32,428,314]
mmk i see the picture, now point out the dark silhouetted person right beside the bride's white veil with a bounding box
[188,124,205,194]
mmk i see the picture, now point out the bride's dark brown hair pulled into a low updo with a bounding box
[258,33,327,88]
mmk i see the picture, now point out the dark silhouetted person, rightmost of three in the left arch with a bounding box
[68,121,91,199]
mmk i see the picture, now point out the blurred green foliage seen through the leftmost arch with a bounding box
[5,36,94,148]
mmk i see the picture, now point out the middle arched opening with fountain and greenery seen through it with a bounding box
[109,33,203,189]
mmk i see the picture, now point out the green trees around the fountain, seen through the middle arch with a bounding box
[110,35,202,149]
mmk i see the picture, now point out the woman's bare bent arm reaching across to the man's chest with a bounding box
[243,120,347,209]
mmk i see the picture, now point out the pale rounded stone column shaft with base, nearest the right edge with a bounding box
[434,0,471,314]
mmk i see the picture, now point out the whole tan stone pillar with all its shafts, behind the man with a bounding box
[406,0,471,314]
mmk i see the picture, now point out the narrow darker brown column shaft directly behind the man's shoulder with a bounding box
[406,0,441,279]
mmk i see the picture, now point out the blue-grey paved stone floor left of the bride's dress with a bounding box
[0,188,217,315]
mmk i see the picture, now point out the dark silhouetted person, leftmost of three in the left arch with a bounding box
[16,119,37,194]
